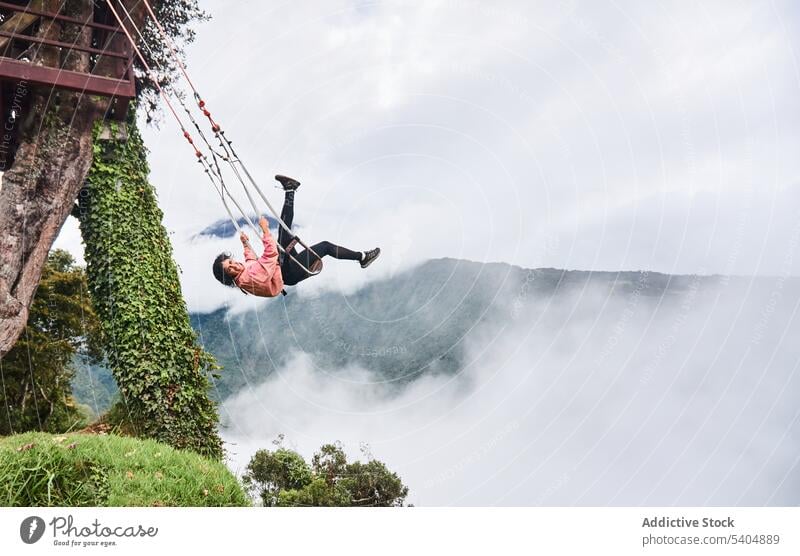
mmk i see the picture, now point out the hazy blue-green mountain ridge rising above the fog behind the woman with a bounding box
[73,257,800,408]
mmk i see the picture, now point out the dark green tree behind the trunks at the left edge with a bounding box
[0,250,100,435]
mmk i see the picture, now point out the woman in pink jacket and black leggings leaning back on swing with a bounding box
[212,175,381,297]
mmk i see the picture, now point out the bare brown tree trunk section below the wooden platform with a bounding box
[0,92,97,357]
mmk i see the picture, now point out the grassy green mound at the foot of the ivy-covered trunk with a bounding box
[0,433,250,507]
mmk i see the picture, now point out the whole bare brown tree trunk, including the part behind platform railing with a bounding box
[0,0,141,358]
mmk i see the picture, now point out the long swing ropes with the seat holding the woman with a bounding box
[106,0,322,276]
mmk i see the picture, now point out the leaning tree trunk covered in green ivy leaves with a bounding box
[76,117,222,458]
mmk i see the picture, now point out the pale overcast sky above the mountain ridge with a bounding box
[58,0,800,310]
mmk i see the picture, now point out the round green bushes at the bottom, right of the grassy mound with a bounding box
[242,444,408,506]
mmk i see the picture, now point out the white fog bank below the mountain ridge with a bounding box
[222,277,800,506]
